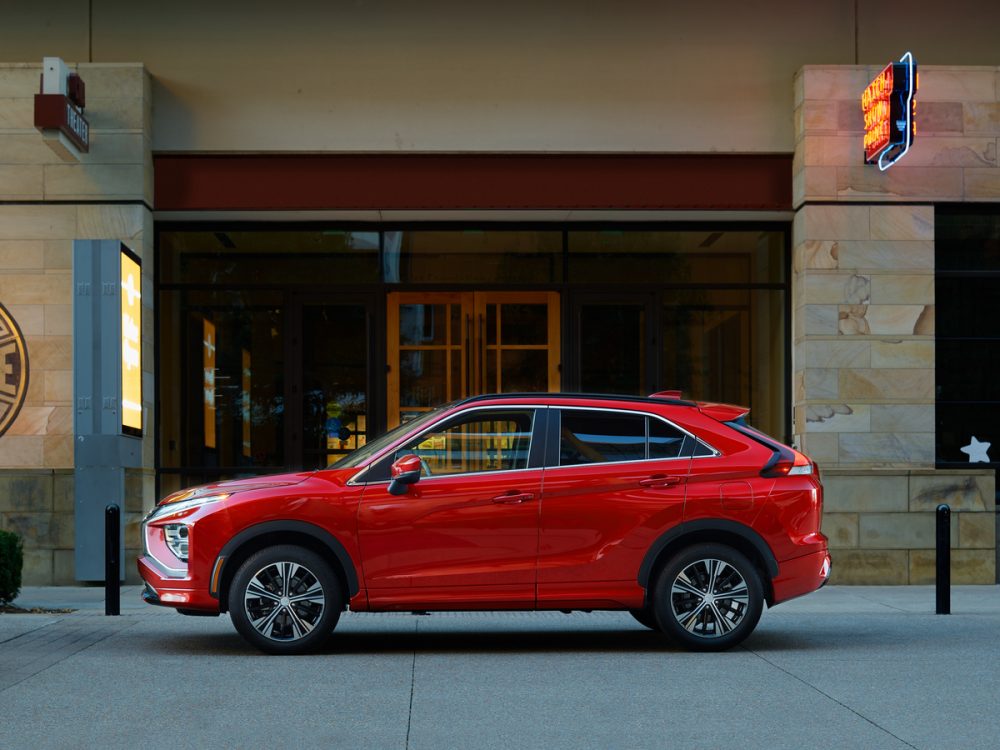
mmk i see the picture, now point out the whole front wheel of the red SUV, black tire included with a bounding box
[229,544,344,654]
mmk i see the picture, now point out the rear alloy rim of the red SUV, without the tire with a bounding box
[670,558,750,638]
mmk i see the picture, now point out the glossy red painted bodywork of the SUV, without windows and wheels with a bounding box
[138,394,829,612]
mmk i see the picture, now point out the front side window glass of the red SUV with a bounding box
[395,410,534,476]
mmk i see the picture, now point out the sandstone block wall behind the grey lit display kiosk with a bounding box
[0,62,155,584]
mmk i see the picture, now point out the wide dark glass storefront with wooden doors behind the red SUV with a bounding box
[157,225,789,494]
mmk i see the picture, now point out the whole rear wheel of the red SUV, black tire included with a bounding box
[653,544,764,651]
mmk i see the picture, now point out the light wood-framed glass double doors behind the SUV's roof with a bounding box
[386,292,560,427]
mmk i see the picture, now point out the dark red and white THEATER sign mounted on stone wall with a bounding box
[35,57,90,161]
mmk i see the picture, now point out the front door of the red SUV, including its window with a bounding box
[358,406,542,609]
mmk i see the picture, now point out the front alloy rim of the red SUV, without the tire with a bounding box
[243,561,326,642]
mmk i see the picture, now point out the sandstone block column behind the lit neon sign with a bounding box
[792,66,1000,583]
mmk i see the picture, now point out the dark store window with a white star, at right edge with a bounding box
[934,205,1000,468]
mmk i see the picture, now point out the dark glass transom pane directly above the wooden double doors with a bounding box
[382,230,562,284]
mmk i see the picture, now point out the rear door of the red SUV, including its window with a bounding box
[538,408,691,607]
